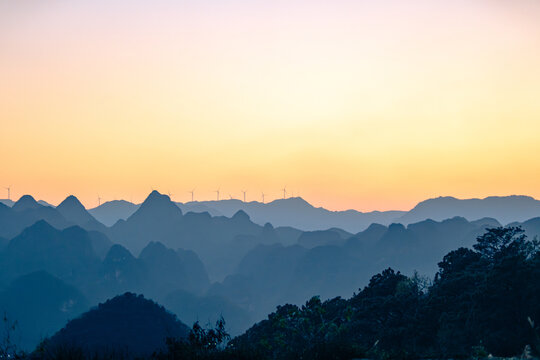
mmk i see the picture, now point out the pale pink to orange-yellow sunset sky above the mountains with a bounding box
[0,0,540,211]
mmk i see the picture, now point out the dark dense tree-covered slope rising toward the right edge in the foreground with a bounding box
[154,227,540,359]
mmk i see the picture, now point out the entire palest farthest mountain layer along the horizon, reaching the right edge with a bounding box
[89,196,540,233]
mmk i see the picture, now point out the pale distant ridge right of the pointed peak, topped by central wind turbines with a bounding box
[178,197,405,233]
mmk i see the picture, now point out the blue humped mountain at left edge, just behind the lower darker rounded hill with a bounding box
[0,220,100,284]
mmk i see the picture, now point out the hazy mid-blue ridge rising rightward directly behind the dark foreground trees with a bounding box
[208,217,500,320]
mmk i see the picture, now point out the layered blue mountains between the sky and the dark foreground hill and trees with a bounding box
[0,191,540,347]
